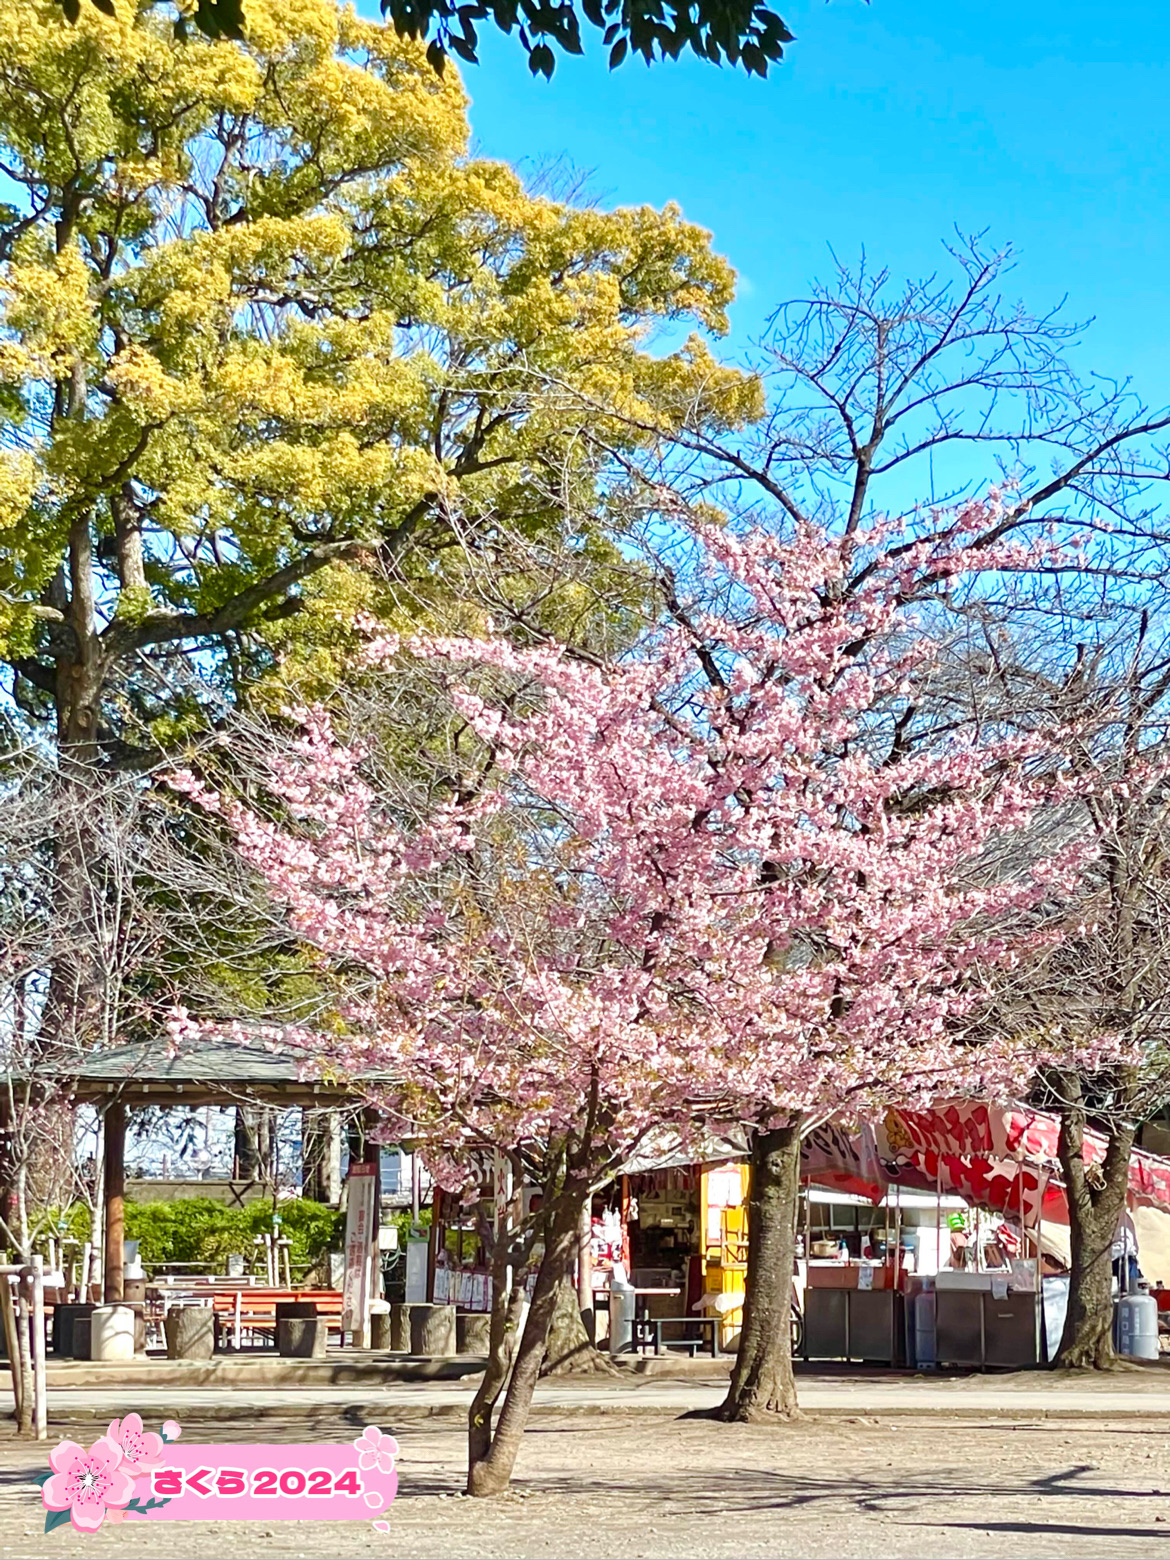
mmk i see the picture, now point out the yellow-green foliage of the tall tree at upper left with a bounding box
[0,0,760,736]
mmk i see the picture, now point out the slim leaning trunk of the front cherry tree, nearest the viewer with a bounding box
[466,1176,587,1494]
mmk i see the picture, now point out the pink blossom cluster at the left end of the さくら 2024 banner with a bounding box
[37,1413,181,1533]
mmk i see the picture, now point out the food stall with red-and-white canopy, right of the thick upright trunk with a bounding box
[802,1101,1170,1368]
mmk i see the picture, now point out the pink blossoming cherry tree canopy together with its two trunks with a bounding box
[176,504,1084,1494]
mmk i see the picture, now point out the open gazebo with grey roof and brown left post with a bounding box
[67,1039,390,1304]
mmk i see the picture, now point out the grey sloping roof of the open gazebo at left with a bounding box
[70,1039,388,1106]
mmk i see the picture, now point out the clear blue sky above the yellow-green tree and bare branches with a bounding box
[411,0,1170,401]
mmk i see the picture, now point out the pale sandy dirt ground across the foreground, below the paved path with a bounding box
[0,1410,1170,1560]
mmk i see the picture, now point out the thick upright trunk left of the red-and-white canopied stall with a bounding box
[719,1120,800,1424]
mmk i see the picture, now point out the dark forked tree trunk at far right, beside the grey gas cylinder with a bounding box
[1056,1084,1136,1370]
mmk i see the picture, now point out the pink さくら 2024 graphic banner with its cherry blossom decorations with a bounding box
[36,1413,398,1533]
